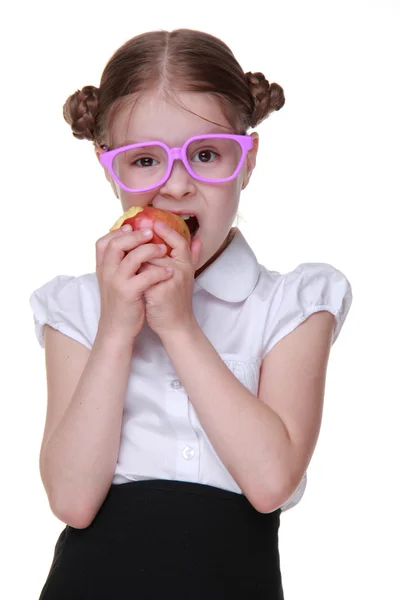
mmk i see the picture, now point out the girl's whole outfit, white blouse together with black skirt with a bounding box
[30,229,352,600]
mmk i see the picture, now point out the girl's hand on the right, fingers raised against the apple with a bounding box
[138,221,202,337]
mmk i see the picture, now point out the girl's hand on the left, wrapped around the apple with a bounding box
[96,228,172,342]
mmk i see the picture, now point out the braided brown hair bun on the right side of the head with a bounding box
[246,72,285,127]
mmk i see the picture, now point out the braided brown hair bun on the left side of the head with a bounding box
[63,85,99,140]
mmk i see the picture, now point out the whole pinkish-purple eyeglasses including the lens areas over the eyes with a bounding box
[100,133,253,193]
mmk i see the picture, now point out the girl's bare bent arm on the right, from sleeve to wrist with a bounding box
[162,311,334,512]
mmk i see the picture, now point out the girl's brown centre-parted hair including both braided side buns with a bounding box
[63,29,285,145]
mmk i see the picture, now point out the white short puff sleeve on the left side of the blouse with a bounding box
[29,275,97,350]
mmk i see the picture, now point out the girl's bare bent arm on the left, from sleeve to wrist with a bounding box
[40,325,132,528]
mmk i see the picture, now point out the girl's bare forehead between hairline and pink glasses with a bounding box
[110,92,233,147]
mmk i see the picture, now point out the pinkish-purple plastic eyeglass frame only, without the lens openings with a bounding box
[100,133,253,194]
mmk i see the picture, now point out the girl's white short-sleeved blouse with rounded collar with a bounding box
[30,229,352,511]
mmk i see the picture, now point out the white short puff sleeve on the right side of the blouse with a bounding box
[264,263,353,356]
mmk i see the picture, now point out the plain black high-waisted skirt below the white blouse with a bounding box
[39,479,284,600]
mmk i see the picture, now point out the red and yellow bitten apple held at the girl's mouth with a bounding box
[110,206,191,256]
